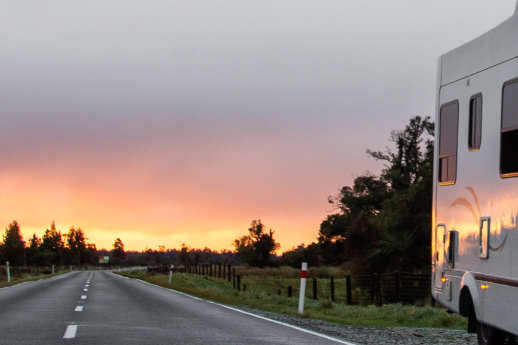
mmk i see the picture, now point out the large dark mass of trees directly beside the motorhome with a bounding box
[282,116,434,274]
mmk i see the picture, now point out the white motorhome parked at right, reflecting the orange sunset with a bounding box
[432,4,518,344]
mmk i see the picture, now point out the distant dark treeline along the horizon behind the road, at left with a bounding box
[0,220,240,267]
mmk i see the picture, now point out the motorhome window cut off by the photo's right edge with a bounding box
[500,79,518,177]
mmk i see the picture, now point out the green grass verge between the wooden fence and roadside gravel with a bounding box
[119,271,467,329]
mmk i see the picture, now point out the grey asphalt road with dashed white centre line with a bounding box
[0,271,358,345]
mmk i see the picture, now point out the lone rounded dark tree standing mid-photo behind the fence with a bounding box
[232,220,280,267]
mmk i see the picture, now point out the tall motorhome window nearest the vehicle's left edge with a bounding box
[439,101,459,185]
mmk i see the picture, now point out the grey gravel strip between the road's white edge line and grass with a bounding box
[232,306,477,345]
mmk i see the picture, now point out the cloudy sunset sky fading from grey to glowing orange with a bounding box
[0,0,516,253]
